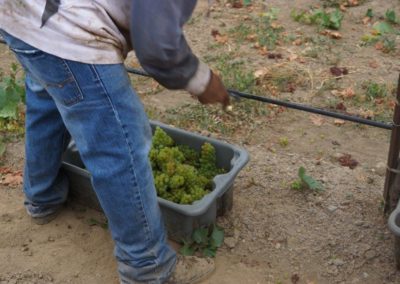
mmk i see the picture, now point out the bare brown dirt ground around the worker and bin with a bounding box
[0,0,400,284]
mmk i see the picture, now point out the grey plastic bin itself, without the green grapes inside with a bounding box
[63,121,249,241]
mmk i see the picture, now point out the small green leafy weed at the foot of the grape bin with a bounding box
[180,224,224,257]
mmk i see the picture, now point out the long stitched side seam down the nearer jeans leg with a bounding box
[90,64,153,245]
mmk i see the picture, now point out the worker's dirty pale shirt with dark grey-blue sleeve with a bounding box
[0,0,210,94]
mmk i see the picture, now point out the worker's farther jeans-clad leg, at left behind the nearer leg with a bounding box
[0,31,69,224]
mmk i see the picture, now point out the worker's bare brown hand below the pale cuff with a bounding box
[197,71,230,109]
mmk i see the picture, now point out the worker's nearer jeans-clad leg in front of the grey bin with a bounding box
[0,30,176,283]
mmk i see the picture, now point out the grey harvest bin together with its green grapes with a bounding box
[63,121,249,241]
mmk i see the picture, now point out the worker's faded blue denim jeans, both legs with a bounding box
[0,30,176,283]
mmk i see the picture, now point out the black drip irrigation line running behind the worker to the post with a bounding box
[0,37,394,130]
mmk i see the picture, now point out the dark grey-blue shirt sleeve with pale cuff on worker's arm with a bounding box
[130,0,211,95]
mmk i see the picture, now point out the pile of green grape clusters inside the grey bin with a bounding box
[149,127,224,204]
